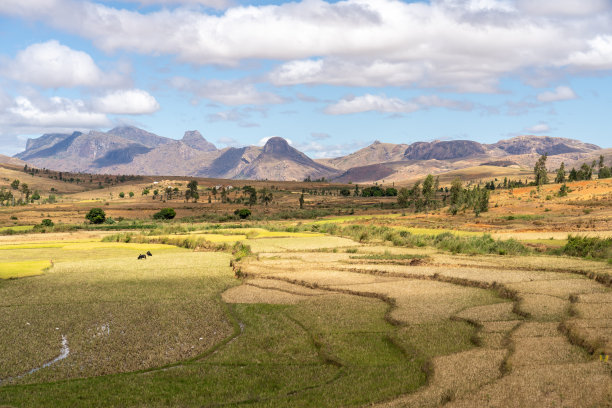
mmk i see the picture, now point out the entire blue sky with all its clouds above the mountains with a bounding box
[0,0,612,158]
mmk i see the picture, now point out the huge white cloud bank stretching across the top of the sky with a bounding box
[0,0,612,91]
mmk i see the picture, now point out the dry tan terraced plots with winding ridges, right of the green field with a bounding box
[237,247,612,407]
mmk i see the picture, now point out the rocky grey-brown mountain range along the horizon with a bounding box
[14,126,607,182]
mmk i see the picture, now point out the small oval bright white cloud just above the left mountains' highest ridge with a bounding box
[93,89,159,115]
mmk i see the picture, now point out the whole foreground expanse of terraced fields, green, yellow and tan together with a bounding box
[0,228,612,407]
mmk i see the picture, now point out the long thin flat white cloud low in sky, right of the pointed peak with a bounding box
[325,94,472,115]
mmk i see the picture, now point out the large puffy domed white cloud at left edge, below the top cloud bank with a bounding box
[2,40,122,88]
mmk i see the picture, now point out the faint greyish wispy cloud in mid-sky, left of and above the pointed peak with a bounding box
[170,77,285,106]
